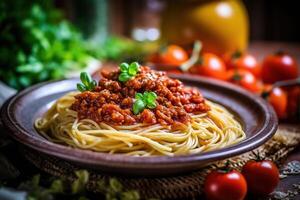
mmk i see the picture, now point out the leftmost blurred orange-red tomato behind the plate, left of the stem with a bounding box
[151,45,189,66]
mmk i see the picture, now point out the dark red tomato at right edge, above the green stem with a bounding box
[261,52,298,83]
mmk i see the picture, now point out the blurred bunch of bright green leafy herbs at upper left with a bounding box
[0,0,92,89]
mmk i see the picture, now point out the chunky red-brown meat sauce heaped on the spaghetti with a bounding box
[71,67,210,125]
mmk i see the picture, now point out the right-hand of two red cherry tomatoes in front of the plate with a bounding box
[242,160,279,195]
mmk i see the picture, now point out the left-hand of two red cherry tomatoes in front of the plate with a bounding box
[204,170,247,200]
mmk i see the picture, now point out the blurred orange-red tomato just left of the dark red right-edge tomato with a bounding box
[223,52,261,77]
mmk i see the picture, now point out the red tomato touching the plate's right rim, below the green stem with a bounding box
[264,85,288,119]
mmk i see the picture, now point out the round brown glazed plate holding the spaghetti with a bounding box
[1,75,278,176]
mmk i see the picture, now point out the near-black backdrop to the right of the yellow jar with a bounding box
[243,0,300,42]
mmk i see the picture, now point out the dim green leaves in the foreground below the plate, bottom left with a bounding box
[13,170,140,200]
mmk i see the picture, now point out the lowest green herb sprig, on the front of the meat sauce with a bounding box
[132,92,157,115]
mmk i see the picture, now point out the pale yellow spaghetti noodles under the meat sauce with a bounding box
[35,92,246,156]
